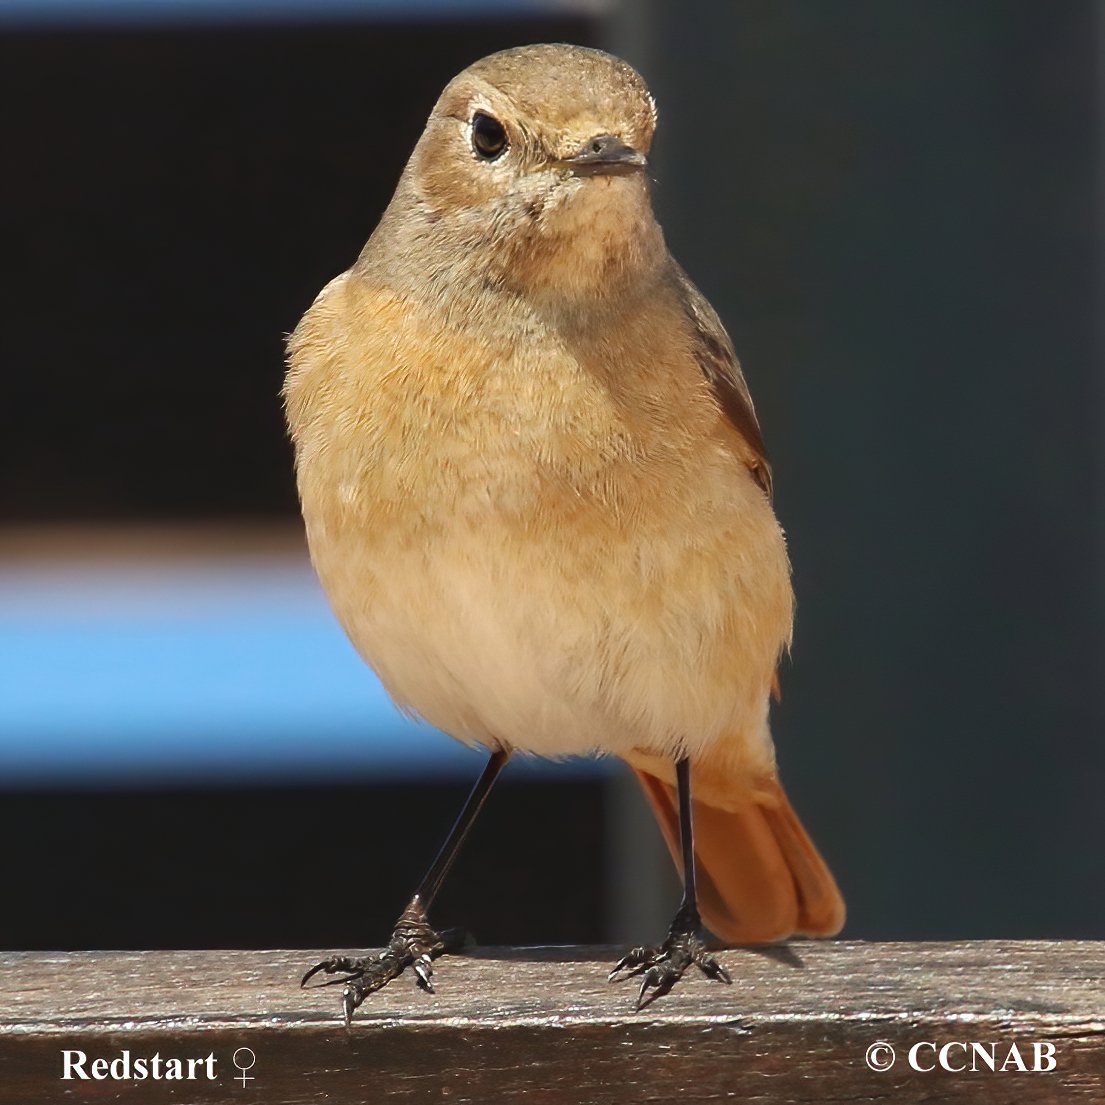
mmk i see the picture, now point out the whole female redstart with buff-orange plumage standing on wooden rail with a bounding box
[283,44,844,1022]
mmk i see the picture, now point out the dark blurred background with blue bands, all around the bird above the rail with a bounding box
[0,0,1105,948]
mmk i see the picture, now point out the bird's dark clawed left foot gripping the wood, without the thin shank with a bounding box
[299,897,453,1024]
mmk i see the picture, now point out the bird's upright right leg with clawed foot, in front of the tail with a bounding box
[610,757,733,1010]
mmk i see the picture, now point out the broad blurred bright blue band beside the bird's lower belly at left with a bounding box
[0,560,602,786]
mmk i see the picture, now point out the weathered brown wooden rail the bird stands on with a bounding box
[0,941,1105,1105]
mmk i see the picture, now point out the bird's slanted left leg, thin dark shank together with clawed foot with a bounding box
[299,749,511,1024]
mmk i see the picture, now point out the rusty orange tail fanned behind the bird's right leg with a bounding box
[633,765,844,944]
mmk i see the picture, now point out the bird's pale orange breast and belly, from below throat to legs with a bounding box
[280,274,792,772]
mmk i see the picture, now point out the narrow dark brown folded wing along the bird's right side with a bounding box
[674,264,771,498]
